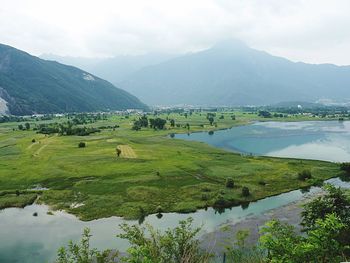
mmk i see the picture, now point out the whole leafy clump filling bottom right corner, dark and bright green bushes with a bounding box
[260,185,350,262]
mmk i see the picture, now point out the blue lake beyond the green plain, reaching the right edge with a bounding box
[174,121,350,162]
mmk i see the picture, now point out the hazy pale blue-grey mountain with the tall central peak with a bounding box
[120,40,350,106]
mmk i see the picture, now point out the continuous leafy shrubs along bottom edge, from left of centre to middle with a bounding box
[56,218,210,263]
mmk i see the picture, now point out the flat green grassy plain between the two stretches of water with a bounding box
[0,112,340,220]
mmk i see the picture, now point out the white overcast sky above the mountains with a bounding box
[0,0,350,65]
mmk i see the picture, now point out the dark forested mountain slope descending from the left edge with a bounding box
[0,44,147,115]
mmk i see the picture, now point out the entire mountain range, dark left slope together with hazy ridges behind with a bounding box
[0,40,350,115]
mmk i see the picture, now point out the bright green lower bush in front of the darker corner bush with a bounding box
[259,214,347,263]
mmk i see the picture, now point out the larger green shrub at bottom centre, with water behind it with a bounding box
[118,218,209,263]
